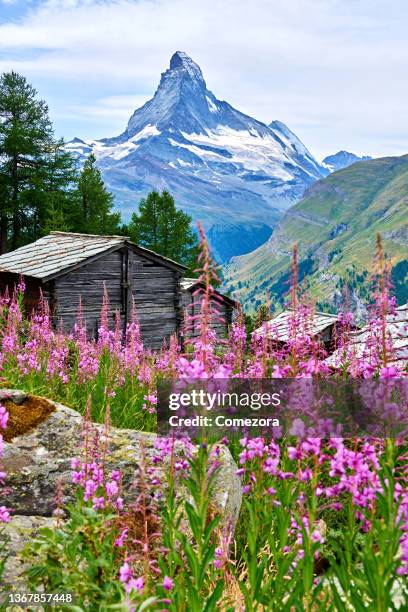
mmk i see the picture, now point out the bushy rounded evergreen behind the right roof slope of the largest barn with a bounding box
[127,191,198,269]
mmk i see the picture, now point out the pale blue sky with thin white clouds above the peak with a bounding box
[0,0,408,158]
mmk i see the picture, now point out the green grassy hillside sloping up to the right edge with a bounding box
[224,155,408,309]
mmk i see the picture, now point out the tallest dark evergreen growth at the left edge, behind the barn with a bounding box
[0,72,75,252]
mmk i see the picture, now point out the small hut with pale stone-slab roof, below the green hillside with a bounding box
[253,308,339,352]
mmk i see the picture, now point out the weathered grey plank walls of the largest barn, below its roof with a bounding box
[54,247,181,349]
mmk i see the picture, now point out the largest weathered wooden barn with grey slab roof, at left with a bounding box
[0,232,185,349]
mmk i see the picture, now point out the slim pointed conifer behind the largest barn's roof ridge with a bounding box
[78,154,120,235]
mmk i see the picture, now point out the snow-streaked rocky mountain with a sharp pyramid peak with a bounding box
[67,51,328,254]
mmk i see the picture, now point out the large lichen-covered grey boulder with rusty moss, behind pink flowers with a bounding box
[0,389,242,528]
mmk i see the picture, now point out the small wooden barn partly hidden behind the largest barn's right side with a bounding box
[181,278,237,338]
